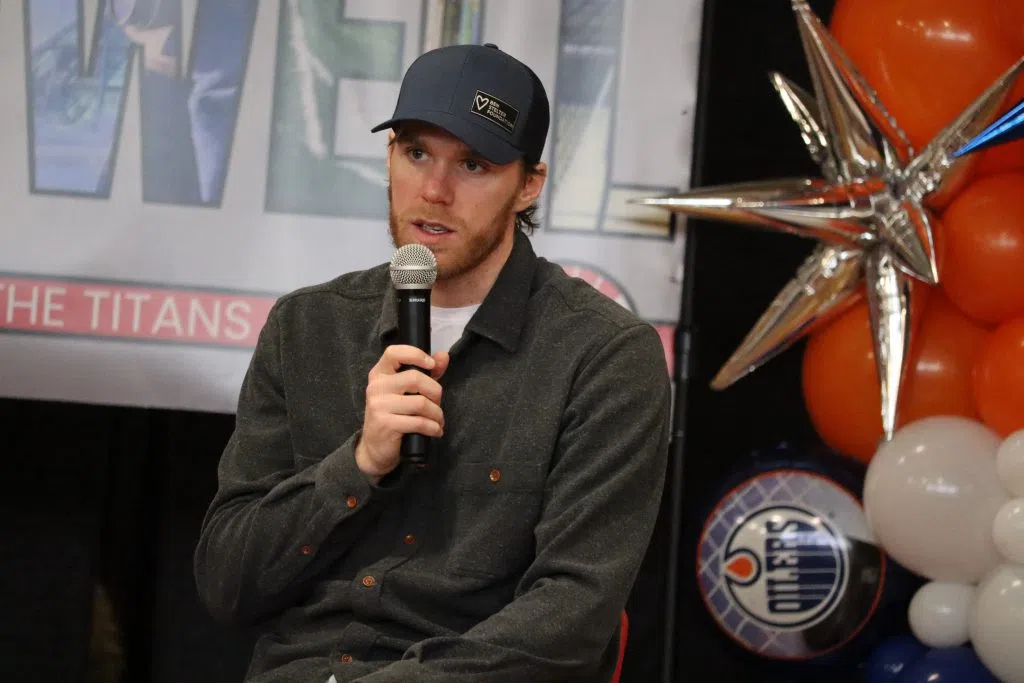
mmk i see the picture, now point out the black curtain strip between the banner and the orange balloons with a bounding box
[663,0,859,683]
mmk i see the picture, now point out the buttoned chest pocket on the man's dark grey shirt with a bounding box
[445,462,547,579]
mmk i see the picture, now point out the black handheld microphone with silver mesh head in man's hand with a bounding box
[391,244,437,465]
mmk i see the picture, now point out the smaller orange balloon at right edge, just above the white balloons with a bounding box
[974,318,1024,436]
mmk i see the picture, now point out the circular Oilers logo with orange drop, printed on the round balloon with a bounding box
[722,505,849,629]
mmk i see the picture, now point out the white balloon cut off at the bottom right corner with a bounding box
[969,564,1024,683]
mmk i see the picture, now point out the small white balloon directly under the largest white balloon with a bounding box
[907,581,974,647]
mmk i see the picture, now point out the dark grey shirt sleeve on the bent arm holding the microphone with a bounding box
[194,306,401,623]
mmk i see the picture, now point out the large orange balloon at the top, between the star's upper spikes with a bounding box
[829,0,1021,151]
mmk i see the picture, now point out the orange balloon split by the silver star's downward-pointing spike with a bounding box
[803,289,986,463]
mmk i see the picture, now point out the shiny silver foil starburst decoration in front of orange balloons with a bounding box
[634,0,1024,440]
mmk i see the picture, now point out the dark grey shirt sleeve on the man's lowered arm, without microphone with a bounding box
[358,325,672,683]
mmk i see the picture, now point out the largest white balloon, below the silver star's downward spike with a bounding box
[864,417,1007,581]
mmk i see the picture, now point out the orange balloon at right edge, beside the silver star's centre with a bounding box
[940,173,1024,324]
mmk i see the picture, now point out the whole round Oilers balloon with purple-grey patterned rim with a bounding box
[696,461,908,661]
